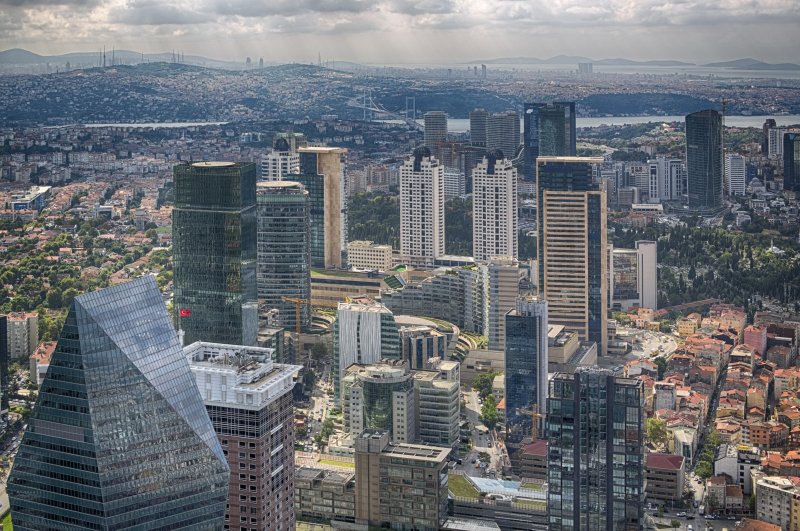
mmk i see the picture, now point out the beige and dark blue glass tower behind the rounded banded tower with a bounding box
[288,146,347,269]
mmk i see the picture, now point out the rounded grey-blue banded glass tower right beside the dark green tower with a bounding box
[256,181,311,331]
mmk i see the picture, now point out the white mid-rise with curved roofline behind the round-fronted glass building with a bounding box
[331,297,401,404]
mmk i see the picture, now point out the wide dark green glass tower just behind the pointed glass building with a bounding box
[172,162,258,345]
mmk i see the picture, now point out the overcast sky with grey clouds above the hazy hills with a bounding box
[0,0,800,63]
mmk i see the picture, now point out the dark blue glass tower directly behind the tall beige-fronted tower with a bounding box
[523,102,577,182]
